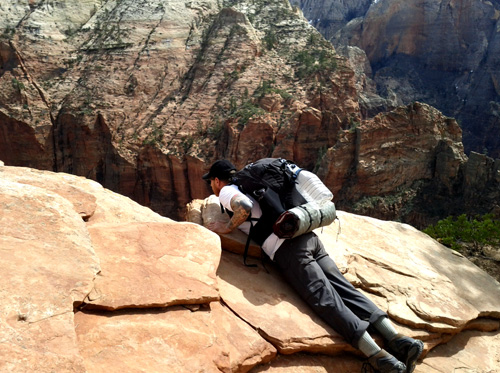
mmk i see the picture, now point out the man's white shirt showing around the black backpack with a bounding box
[219,185,285,260]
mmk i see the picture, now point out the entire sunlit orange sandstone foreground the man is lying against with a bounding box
[0,163,500,373]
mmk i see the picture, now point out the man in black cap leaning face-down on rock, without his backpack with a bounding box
[203,160,424,373]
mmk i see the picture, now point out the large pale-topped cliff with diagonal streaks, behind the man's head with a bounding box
[0,0,358,217]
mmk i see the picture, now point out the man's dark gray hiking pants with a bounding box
[274,233,387,348]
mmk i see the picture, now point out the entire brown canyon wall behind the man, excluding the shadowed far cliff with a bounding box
[0,0,500,227]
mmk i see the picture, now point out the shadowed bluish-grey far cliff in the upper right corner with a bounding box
[292,0,500,158]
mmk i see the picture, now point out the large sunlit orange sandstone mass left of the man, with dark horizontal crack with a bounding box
[0,166,275,372]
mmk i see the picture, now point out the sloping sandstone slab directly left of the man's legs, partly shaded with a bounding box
[217,252,352,354]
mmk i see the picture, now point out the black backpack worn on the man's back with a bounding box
[228,158,306,266]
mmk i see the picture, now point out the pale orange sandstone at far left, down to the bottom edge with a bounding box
[0,178,100,372]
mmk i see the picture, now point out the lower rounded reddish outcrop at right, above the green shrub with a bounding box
[318,102,500,228]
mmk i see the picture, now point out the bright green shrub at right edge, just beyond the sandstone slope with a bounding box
[424,214,500,250]
